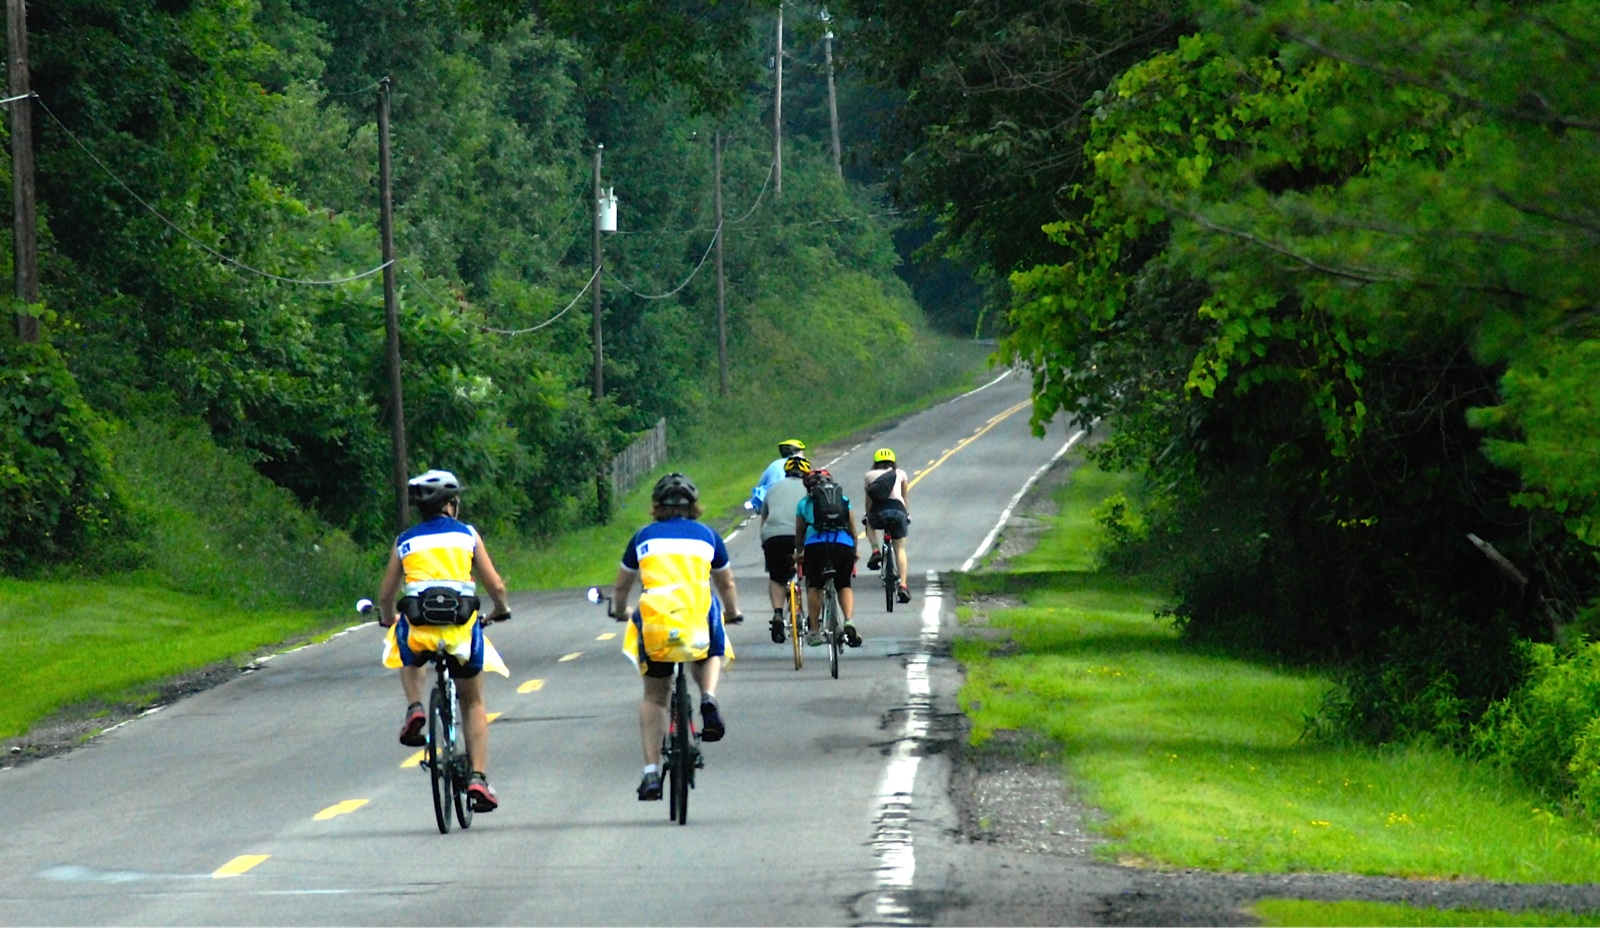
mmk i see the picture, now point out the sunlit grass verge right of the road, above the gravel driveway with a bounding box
[955,467,1600,882]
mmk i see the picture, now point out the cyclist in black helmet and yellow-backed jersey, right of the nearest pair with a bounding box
[611,474,744,800]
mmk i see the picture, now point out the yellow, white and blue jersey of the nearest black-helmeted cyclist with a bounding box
[622,518,733,674]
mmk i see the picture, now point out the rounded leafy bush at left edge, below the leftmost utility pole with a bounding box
[0,338,128,576]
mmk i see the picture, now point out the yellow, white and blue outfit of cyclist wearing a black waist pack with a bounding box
[382,515,510,677]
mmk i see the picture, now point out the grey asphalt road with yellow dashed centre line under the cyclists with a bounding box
[0,366,1074,925]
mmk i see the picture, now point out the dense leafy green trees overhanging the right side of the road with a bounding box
[1005,3,1600,736]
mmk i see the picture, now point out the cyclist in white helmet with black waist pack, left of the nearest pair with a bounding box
[378,470,510,811]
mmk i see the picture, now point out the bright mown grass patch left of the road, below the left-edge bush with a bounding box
[0,579,331,738]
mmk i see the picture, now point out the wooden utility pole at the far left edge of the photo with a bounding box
[6,0,38,342]
